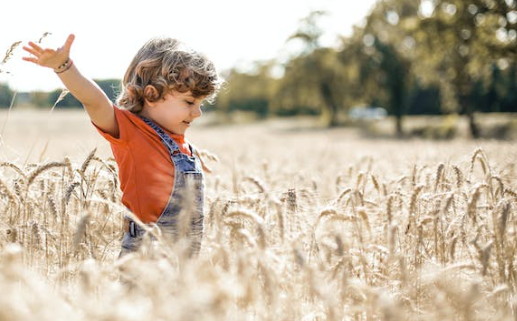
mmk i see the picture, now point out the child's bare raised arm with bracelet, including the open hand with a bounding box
[22,34,119,137]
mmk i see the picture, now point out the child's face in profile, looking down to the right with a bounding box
[142,91,204,135]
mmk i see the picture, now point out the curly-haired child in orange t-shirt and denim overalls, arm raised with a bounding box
[23,35,221,254]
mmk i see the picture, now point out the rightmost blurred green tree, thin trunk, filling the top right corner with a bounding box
[404,0,517,138]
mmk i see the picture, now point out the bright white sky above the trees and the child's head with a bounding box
[0,0,376,91]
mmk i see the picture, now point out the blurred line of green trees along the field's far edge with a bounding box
[0,0,517,137]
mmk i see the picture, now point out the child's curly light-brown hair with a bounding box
[117,38,222,113]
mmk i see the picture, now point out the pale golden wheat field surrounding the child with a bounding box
[0,111,517,321]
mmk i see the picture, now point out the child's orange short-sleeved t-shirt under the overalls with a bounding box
[94,107,191,223]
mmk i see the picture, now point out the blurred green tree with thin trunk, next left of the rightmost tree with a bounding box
[340,0,418,136]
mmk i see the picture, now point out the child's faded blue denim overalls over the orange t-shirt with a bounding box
[120,116,204,255]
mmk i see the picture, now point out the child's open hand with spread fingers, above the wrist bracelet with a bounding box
[22,34,75,69]
